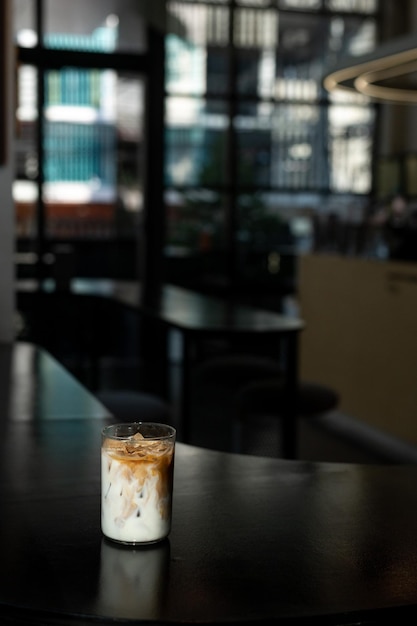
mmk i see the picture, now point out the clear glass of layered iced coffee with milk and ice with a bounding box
[101,422,176,544]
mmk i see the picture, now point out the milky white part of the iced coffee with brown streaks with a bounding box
[101,450,171,542]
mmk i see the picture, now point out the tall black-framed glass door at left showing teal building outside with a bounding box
[13,0,147,286]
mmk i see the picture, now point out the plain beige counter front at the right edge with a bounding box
[299,255,417,444]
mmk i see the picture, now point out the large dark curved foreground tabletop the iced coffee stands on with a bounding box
[0,346,417,626]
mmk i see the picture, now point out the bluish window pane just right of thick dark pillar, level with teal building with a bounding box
[165,98,228,186]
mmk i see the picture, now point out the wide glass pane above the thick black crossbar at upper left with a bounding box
[44,0,146,52]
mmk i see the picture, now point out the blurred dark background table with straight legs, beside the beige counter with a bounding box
[140,285,304,448]
